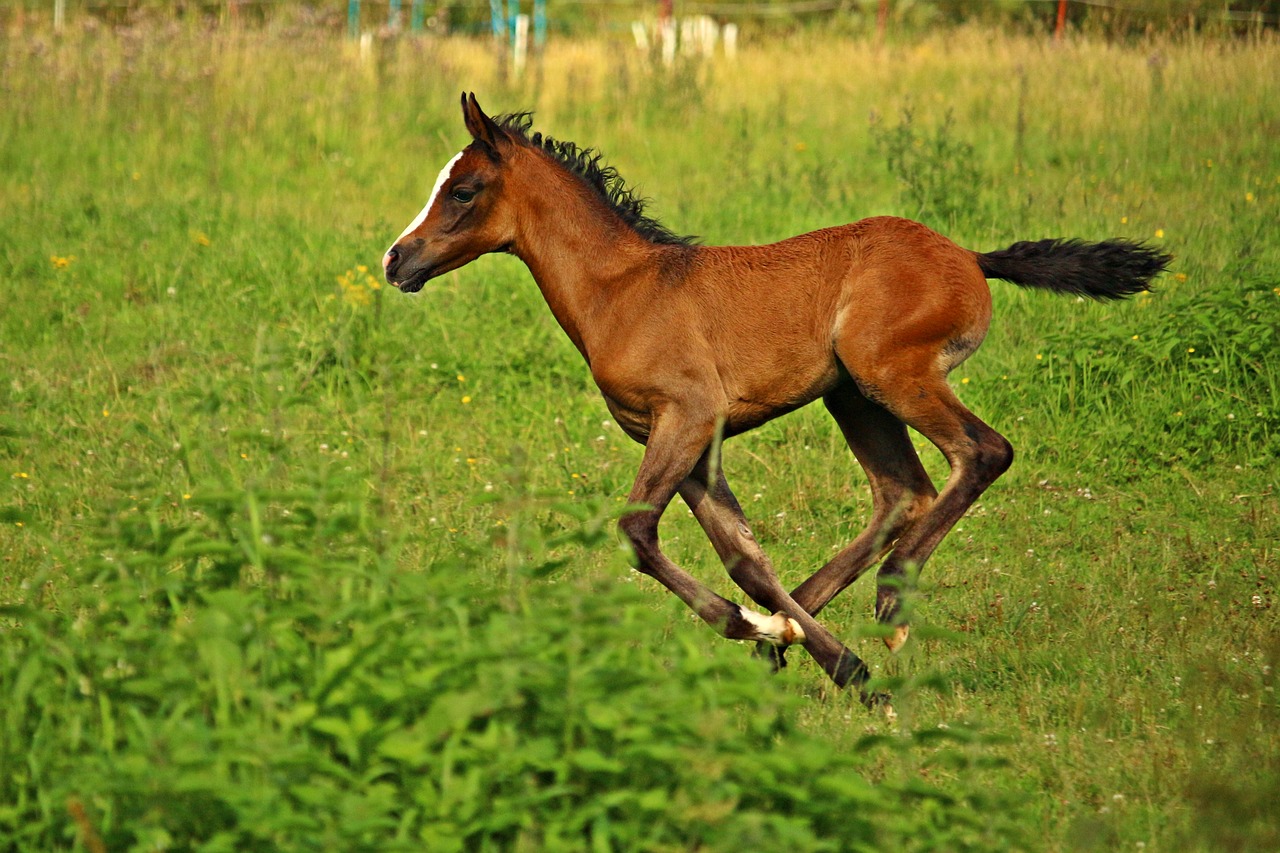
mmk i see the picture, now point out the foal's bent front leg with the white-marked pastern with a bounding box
[618,411,804,646]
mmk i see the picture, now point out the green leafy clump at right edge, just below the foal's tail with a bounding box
[1038,257,1280,465]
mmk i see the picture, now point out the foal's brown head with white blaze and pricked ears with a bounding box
[383,95,518,293]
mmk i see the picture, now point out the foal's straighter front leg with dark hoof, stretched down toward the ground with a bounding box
[680,447,883,704]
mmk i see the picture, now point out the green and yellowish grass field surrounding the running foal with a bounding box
[0,14,1280,850]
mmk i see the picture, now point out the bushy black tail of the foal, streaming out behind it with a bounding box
[978,240,1174,300]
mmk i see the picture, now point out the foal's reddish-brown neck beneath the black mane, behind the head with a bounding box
[512,180,662,361]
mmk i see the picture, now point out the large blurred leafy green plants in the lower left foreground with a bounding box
[0,473,1014,850]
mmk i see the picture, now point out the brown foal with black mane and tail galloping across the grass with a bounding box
[383,93,1171,706]
